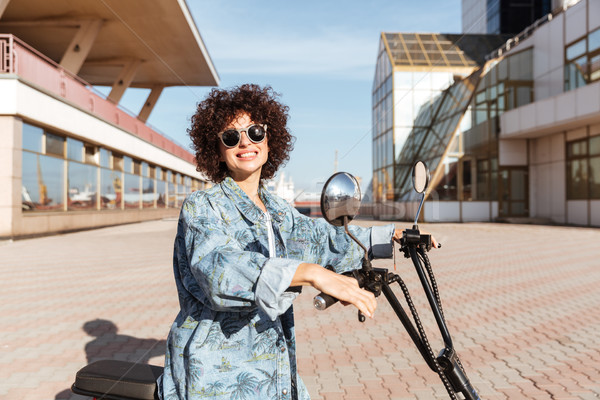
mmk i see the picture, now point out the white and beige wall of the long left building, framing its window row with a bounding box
[0,75,200,238]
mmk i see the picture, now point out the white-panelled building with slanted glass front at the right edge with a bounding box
[373,0,600,226]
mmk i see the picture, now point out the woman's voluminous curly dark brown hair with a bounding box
[187,84,294,183]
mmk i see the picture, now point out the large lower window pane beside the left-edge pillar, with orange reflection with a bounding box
[21,152,64,211]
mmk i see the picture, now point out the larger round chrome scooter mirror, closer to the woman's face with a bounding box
[321,172,360,226]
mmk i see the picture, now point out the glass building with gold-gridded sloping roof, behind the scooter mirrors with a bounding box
[372,32,510,218]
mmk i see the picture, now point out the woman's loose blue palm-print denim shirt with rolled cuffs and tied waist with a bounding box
[158,178,394,400]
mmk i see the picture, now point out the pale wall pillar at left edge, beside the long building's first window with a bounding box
[0,116,23,238]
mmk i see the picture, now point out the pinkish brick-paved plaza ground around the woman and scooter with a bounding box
[0,219,600,400]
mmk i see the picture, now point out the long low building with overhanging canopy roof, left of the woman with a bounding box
[0,0,218,238]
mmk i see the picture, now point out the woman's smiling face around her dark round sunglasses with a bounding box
[219,112,269,181]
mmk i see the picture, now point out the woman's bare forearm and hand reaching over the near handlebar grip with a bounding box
[290,263,377,318]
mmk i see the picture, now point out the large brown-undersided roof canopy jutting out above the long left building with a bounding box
[0,0,219,87]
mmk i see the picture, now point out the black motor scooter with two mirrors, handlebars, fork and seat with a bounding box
[71,161,480,400]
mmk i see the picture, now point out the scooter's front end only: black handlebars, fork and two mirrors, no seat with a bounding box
[314,161,480,400]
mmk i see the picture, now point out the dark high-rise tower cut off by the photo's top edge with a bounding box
[462,0,562,35]
